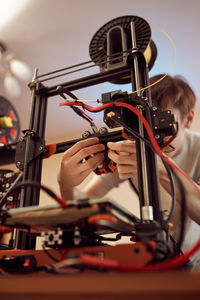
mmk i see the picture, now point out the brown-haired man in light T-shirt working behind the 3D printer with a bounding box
[58,74,200,266]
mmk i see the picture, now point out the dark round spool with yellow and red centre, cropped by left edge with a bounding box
[0,96,20,146]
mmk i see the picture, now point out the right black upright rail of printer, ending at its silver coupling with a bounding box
[131,22,162,222]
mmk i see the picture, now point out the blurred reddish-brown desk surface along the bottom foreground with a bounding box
[0,271,200,300]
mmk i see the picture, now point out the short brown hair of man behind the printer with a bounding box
[150,74,196,119]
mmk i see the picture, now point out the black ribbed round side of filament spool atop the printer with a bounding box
[89,16,151,68]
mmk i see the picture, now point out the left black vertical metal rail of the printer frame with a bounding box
[17,69,47,250]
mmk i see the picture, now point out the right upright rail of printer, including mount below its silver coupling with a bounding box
[128,22,167,261]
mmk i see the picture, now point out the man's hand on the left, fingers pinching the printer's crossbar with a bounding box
[58,137,105,199]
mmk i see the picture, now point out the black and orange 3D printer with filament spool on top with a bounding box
[1,16,198,272]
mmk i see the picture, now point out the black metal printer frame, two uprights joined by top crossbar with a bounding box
[14,49,166,253]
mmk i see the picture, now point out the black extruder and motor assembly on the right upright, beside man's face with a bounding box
[101,90,177,147]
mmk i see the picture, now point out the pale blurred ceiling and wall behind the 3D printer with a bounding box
[0,0,200,143]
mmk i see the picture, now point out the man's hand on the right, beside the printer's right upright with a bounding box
[107,141,137,179]
